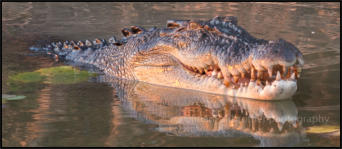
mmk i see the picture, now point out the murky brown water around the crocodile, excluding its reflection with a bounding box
[2,2,340,146]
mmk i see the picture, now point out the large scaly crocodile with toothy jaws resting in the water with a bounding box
[30,16,304,100]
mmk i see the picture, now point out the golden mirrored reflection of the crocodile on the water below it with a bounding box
[100,76,305,146]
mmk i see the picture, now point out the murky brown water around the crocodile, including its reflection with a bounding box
[2,3,340,146]
